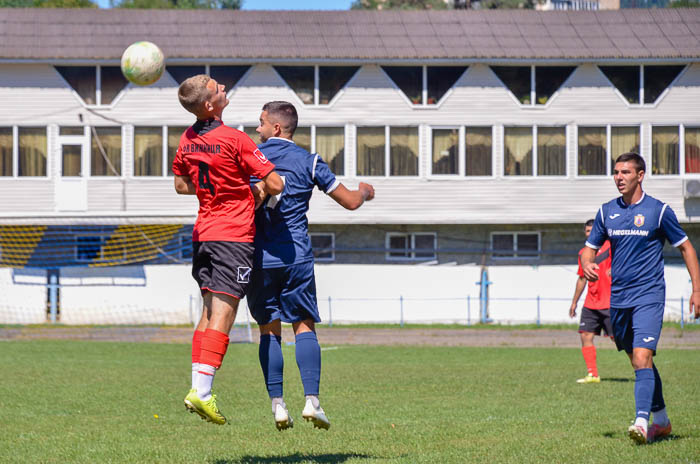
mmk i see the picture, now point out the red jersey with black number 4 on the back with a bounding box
[173,119,275,243]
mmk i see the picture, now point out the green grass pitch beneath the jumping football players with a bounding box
[0,341,700,464]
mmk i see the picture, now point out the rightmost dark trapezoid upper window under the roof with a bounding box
[598,65,685,104]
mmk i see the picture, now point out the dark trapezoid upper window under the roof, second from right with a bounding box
[491,66,576,105]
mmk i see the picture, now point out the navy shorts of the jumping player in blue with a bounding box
[246,261,321,325]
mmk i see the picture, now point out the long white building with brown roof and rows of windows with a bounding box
[0,9,700,322]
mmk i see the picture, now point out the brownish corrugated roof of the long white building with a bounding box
[0,8,700,62]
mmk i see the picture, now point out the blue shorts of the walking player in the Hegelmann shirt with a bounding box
[610,303,665,353]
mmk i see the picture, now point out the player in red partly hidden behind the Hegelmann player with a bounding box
[569,219,613,383]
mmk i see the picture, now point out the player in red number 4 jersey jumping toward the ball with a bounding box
[173,74,284,424]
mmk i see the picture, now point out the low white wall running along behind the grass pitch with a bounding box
[0,264,691,324]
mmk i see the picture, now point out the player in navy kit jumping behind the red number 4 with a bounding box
[247,101,374,430]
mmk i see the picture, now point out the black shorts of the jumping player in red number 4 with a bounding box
[192,242,254,299]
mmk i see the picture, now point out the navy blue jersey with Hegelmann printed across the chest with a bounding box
[586,194,688,308]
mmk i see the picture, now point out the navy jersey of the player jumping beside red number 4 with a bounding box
[255,137,340,269]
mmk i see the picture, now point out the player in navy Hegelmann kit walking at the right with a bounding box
[581,153,700,444]
